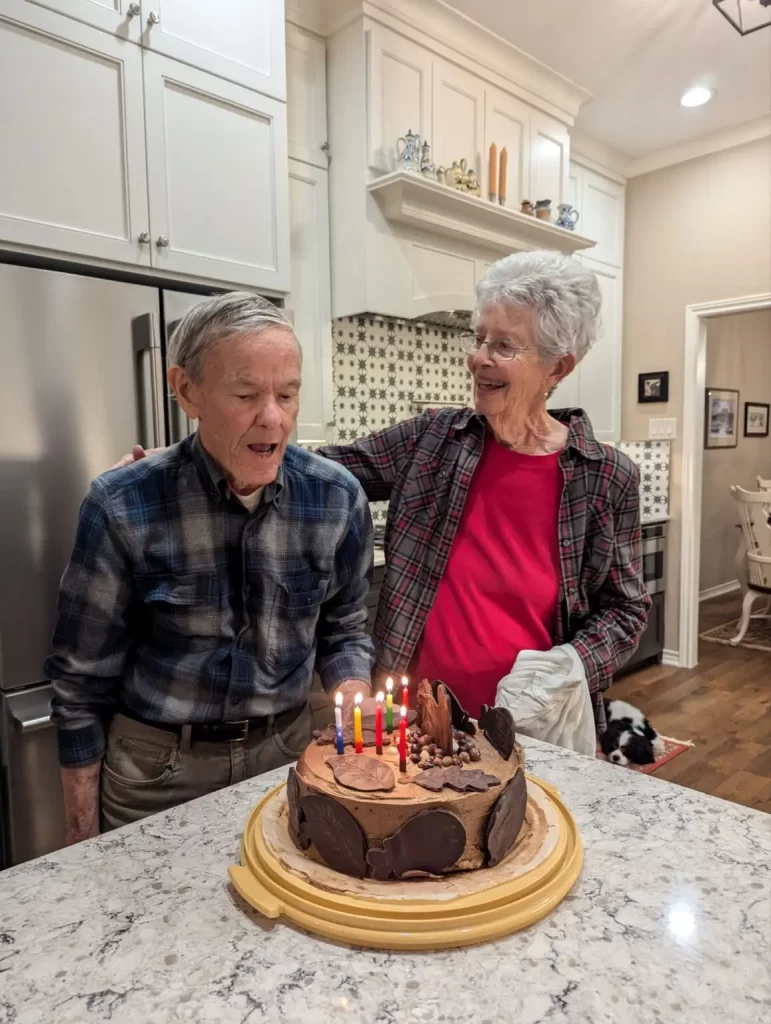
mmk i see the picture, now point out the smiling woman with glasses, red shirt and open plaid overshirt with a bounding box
[320,252,649,732]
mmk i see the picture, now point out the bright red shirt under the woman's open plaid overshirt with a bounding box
[411,435,563,718]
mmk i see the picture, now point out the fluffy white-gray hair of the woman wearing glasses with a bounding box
[474,249,602,362]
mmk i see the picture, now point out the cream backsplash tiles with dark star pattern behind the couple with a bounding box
[333,316,670,523]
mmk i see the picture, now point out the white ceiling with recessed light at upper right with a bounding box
[444,0,771,158]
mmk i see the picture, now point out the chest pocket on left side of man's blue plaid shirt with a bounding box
[136,572,222,639]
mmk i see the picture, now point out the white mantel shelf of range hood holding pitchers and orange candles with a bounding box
[368,171,595,256]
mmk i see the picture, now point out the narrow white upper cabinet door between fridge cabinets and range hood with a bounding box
[287,25,329,170]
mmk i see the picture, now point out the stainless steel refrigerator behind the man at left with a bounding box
[0,264,217,866]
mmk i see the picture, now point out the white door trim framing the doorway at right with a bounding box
[680,292,771,669]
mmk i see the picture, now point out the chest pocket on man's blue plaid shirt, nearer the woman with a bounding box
[265,572,331,674]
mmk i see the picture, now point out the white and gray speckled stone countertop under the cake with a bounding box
[0,740,771,1024]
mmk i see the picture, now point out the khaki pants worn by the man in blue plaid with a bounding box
[100,707,311,831]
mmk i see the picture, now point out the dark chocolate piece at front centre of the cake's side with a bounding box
[367,806,466,882]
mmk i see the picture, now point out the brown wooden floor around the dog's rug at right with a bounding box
[606,595,771,812]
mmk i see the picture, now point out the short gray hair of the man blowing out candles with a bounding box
[168,292,302,383]
